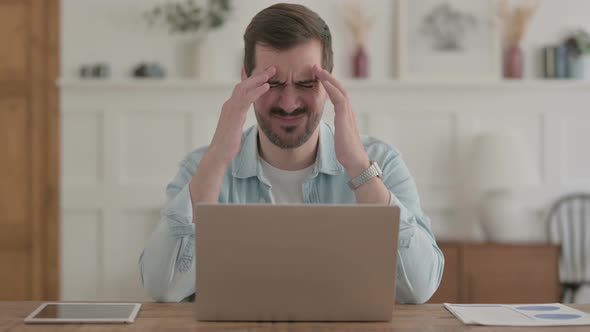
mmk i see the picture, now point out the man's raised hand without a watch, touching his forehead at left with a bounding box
[207,67,276,166]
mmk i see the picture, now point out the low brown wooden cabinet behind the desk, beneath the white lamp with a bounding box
[429,243,561,303]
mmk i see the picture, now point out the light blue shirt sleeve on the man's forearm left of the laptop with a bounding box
[139,160,196,302]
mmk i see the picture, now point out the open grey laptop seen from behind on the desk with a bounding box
[195,204,400,321]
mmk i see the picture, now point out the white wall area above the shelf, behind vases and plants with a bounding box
[62,0,590,79]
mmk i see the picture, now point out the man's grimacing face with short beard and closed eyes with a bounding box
[253,40,327,149]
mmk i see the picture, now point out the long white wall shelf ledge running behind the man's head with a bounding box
[57,78,590,91]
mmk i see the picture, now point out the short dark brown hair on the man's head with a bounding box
[244,3,334,76]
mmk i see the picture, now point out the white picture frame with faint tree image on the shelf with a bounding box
[396,0,502,82]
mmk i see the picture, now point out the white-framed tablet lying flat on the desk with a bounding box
[25,302,141,324]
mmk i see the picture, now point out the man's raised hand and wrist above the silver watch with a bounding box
[313,66,370,178]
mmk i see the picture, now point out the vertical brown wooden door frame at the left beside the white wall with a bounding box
[27,0,61,300]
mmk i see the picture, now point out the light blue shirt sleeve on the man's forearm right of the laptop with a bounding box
[383,149,444,303]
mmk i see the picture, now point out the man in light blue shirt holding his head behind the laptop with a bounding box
[139,4,444,303]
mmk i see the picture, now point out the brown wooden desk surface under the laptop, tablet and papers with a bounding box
[0,302,590,332]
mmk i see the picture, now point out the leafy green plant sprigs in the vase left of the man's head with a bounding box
[144,0,232,33]
